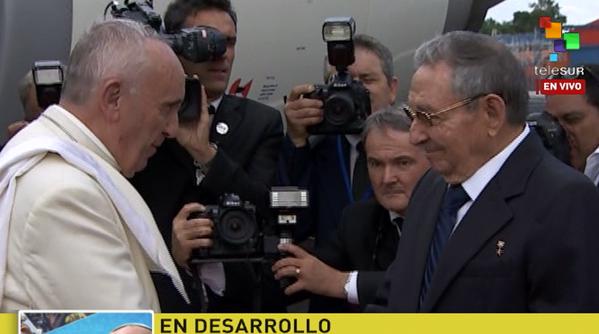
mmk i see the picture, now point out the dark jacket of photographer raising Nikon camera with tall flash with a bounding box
[279,135,372,247]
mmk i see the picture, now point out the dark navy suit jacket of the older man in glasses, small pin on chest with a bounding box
[370,134,599,312]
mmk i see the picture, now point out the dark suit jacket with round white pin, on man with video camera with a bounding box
[132,95,283,312]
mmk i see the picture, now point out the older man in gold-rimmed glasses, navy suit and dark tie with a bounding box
[373,32,599,312]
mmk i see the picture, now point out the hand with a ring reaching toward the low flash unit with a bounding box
[272,244,349,298]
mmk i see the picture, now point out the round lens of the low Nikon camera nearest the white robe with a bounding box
[216,210,258,245]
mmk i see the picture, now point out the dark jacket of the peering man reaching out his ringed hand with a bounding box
[310,199,399,312]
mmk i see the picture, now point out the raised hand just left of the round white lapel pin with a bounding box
[177,82,216,163]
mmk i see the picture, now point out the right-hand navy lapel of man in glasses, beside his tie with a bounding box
[422,133,545,312]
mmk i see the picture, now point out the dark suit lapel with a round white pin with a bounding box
[210,95,246,145]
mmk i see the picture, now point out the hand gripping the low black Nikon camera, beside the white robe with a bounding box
[171,203,214,269]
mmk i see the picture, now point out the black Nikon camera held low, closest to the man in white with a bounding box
[189,194,262,260]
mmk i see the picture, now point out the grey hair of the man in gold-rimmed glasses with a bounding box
[414,31,528,124]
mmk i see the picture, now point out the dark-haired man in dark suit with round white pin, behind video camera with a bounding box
[132,0,283,312]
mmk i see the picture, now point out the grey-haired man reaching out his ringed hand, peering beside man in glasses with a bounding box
[273,107,429,312]
